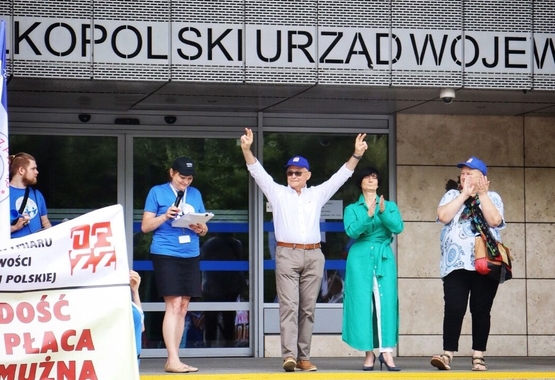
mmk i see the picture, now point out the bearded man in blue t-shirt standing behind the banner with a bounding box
[10,152,52,239]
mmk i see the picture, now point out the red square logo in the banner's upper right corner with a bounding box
[69,222,116,275]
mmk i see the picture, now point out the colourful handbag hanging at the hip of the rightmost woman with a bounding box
[474,232,513,284]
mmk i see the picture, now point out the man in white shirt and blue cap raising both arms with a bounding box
[241,128,368,372]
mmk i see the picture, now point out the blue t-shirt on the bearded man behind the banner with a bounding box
[10,186,47,239]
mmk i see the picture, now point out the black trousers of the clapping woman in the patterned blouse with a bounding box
[443,269,499,351]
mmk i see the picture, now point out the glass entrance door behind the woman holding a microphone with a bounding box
[133,137,252,357]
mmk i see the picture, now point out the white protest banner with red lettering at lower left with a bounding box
[0,205,139,380]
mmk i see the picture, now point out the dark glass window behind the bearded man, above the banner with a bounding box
[10,135,118,220]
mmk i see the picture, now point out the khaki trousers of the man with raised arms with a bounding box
[276,247,325,360]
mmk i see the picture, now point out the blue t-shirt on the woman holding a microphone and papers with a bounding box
[144,183,206,258]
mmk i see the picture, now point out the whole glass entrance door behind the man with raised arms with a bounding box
[263,128,390,342]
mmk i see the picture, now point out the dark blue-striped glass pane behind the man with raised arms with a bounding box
[264,133,389,302]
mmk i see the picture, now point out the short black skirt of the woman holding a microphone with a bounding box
[150,254,201,297]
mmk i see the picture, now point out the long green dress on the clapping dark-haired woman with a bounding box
[342,195,404,351]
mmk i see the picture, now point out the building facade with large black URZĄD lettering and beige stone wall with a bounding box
[0,0,555,356]
